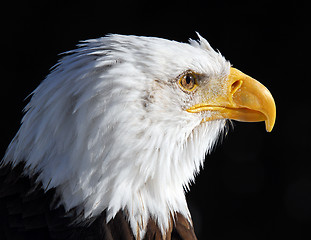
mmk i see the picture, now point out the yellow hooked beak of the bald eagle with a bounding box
[187,68,276,132]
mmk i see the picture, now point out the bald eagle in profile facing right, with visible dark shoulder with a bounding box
[0,34,276,240]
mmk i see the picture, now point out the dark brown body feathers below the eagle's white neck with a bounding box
[0,164,196,240]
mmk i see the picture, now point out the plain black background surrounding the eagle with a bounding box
[0,0,311,240]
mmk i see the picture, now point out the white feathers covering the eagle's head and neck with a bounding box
[4,35,230,236]
